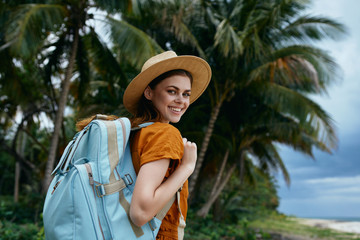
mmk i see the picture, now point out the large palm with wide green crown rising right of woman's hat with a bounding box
[110,0,343,202]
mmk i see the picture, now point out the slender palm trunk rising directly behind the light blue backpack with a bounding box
[42,28,79,194]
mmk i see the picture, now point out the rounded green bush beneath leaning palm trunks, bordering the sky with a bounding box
[192,163,279,225]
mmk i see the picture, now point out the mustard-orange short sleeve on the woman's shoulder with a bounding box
[139,123,184,166]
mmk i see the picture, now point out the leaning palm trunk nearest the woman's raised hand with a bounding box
[189,101,222,197]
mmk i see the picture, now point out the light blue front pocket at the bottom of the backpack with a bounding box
[43,165,104,240]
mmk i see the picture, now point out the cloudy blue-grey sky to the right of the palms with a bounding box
[277,0,360,218]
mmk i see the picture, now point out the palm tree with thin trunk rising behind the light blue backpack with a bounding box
[2,0,164,192]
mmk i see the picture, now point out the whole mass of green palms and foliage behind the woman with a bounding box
[0,0,346,239]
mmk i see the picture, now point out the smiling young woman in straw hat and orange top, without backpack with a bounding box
[124,51,211,240]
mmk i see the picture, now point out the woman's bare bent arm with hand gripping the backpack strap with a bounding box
[130,139,197,226]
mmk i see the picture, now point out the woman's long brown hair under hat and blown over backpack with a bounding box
[76,69,193,131]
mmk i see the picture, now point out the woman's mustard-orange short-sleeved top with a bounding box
[130,122,189,240]
